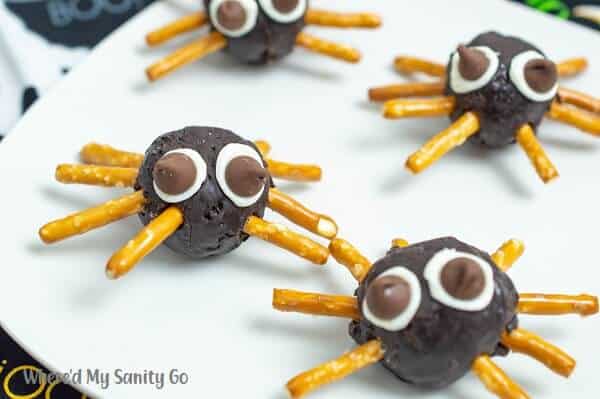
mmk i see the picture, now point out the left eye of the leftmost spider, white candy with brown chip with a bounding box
[152,148,206,204]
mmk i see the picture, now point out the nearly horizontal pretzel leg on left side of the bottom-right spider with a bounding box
[273,289,360,320]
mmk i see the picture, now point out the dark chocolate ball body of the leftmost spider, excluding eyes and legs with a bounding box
[135,126,271,258]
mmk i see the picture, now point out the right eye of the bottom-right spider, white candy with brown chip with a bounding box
[423,249,494,312]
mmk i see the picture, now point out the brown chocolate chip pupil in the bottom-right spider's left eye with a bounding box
[366,276,411,320]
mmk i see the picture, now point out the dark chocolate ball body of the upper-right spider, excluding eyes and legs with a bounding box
[446,32,551,147]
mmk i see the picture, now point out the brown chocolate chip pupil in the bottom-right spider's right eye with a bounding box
[441,258,485,300]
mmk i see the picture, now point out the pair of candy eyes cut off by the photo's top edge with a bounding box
[209,0,307,37]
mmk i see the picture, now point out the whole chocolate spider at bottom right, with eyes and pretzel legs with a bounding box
[273,237,598,399]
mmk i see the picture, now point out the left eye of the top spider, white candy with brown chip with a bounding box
[209,0,258,37]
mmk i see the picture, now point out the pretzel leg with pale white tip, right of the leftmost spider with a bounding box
[269,188,338,239]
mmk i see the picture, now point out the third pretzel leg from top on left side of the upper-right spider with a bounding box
[383,97,456,119]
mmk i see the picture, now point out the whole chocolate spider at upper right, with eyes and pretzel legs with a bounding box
[369,32,600,183]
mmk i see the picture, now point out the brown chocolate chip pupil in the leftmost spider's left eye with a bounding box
[152,153,198,195]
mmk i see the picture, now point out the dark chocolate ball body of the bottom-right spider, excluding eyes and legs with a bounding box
[349,237,518,388]
